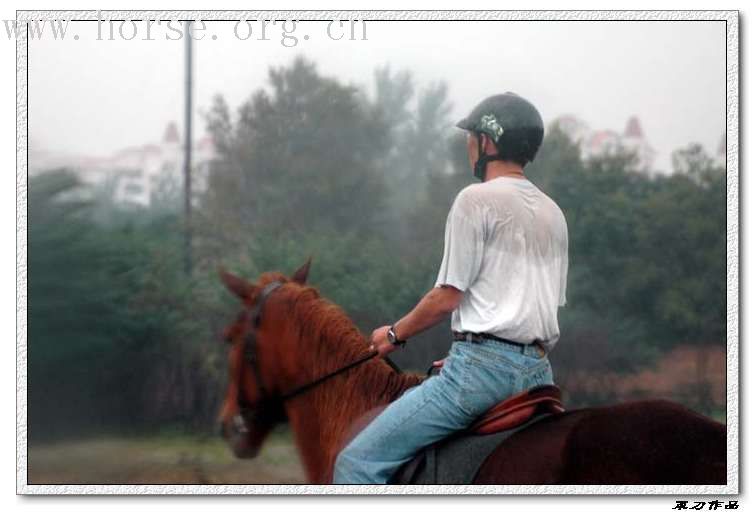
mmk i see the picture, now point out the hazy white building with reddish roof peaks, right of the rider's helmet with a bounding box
[554,115,656,170]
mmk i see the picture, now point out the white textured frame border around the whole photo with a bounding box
[16,10,740,495]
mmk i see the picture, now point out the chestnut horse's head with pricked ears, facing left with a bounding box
[220,261,310,458]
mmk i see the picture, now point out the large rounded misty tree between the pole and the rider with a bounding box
[203,58,387,245]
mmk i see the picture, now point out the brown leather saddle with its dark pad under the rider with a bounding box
[390,385,564,484]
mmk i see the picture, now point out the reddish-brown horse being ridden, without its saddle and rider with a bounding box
[220,263,726,484]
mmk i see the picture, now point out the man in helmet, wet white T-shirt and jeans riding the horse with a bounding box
[333,93,568,484]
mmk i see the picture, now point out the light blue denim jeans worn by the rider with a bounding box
[333,340,553,484]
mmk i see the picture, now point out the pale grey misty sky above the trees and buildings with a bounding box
[29,21,726,169]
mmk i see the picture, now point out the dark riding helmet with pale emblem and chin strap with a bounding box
[456,92,544,181]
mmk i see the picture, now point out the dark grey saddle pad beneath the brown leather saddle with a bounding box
[388,413,551,485]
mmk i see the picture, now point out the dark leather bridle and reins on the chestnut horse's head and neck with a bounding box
[233,281,390,433]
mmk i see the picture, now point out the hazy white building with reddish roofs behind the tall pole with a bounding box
[29,122,215,207]
